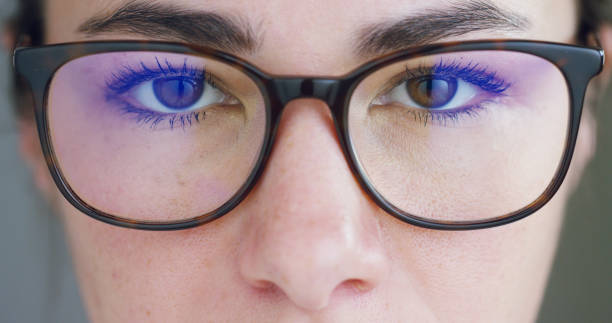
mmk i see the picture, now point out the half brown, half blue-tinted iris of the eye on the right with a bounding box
[406,76,457,109]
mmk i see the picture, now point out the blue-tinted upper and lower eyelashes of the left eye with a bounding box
[105,57,216,130]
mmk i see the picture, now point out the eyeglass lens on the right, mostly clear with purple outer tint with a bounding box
[348,51,570,222]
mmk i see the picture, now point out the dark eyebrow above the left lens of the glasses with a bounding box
[78,0,258,53]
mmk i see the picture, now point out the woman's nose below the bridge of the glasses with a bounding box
[239,99,388,311]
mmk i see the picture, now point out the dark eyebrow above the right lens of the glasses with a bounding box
[357,0,530,56]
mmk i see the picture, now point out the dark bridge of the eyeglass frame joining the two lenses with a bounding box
[273,77,341,109]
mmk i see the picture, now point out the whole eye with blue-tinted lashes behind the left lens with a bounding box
[105,57,239,129]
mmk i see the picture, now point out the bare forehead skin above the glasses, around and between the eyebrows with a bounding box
[46,0,577,74]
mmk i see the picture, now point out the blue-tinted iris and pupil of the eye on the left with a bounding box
[153,76,204,110]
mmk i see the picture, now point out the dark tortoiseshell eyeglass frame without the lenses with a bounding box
[13,40,604,230]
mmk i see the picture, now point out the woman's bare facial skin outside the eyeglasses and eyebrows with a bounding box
[29,0,592,322]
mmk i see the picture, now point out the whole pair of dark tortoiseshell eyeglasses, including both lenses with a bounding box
[14,40,604,230]
